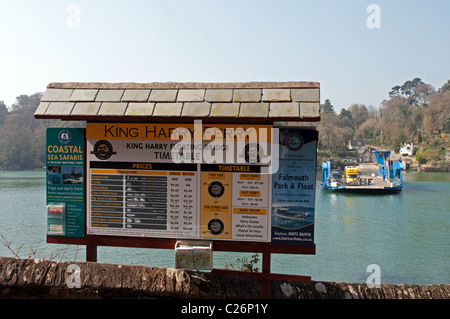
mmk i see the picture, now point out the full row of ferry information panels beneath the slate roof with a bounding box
[47,123,317,245]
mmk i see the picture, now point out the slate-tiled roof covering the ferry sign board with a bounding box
[34,82,320,123]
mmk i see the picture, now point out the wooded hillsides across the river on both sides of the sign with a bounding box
[0,78,450,170]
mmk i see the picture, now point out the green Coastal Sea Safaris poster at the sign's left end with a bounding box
[46,128,85,237]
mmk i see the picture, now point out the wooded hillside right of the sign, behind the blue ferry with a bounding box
[318,78,450,163]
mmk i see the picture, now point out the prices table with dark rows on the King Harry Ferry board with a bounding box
[88,168,197,238]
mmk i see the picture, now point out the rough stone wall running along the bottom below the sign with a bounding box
[0,257,450,299]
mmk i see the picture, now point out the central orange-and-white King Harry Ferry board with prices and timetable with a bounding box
[86,123,272,242]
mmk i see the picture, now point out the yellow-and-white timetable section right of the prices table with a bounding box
[200,165,270,241]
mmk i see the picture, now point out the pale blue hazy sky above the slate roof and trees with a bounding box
[0,0,450,111]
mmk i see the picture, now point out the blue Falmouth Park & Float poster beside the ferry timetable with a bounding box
[272,128,318,245]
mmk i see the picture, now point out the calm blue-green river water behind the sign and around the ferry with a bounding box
[0,171,450,284]
